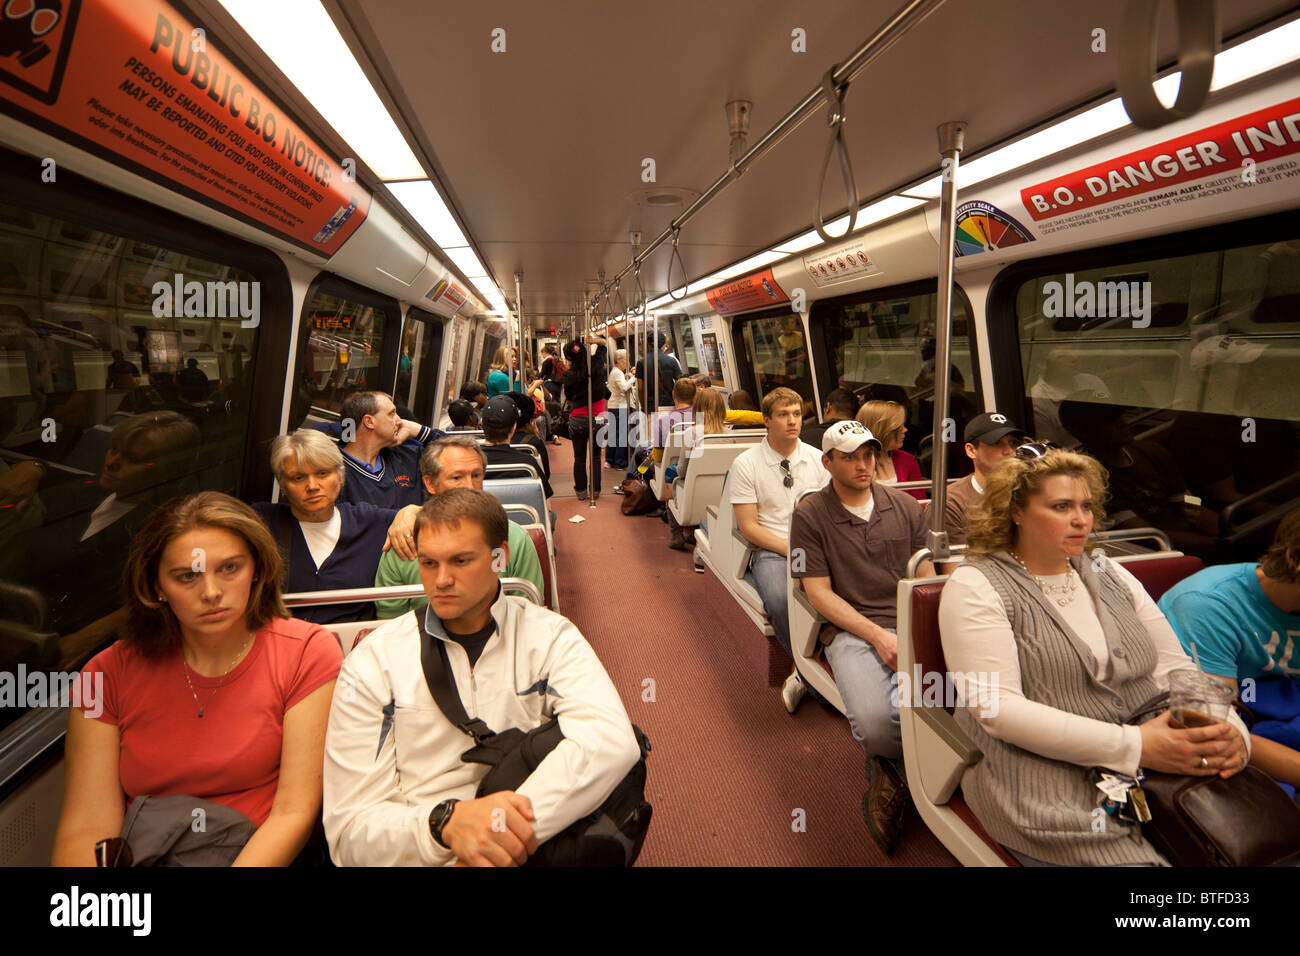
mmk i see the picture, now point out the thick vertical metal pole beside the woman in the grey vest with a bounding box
[928,122,966,562]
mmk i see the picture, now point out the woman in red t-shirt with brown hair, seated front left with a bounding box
[53,492,342,866]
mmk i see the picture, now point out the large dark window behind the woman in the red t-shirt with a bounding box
[0,197,267,724]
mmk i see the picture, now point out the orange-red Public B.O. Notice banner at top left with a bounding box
[0,0,371,256]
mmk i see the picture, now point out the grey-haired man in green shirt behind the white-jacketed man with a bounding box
[374,436,546,618]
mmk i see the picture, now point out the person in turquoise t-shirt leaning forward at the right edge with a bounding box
[1158,509,1300,787]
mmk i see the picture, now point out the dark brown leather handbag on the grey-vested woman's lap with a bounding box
[1125,693,1300,866]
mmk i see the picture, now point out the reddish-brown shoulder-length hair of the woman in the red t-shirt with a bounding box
[122,492,289,657]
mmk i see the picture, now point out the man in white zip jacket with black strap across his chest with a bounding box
[324,489,640,866]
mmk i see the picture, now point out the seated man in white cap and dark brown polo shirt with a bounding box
[790,421,935,853]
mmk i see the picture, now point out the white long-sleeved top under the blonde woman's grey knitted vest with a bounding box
[939,562,1251,777]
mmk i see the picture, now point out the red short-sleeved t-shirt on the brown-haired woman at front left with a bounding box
[81,618,343,826]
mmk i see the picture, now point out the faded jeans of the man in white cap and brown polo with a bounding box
[826,628,902,760]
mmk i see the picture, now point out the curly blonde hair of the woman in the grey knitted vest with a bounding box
[966,449,1109,554]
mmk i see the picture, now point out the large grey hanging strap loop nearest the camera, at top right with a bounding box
[1119,0,1219,130]
